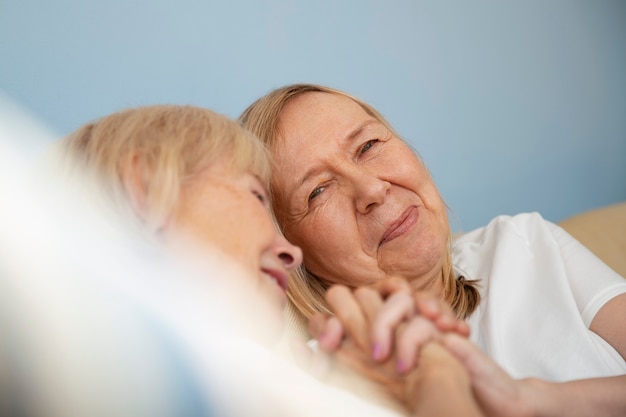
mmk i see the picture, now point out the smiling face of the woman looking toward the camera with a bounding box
[272,92,449,289]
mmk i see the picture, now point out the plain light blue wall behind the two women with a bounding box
[0,0,626,231]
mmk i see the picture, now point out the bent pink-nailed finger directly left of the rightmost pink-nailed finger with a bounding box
[372,291,415,361]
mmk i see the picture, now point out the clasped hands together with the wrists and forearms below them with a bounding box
[298,278,538,417]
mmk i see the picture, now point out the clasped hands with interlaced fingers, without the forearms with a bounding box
[302,278,470,408]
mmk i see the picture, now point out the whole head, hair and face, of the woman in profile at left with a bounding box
[58,105,302,324]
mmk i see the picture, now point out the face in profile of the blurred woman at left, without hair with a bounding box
[170,158,302,309]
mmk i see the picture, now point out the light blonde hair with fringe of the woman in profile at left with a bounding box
[56,105,270,231]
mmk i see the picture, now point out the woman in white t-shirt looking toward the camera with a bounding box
[240,84,626,415]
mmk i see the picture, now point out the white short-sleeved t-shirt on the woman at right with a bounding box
[452,213,626,381]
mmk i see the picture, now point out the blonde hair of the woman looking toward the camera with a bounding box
[239,84,480,318]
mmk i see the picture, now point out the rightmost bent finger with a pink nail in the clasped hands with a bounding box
[396,316,441,373]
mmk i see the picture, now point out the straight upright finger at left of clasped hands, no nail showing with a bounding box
[320,285,370,351]
